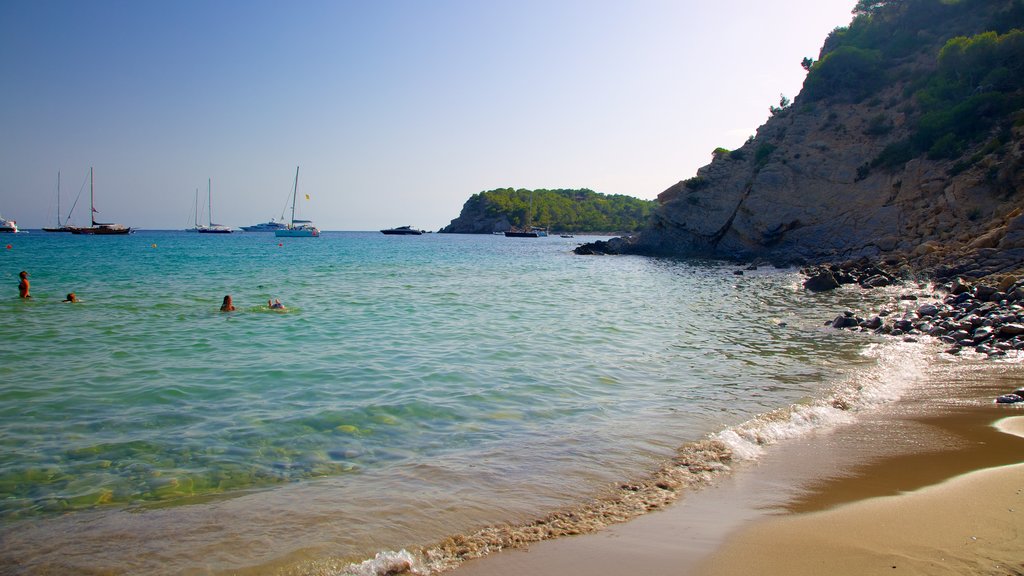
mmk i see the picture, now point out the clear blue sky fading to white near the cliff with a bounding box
[0,0,856,231]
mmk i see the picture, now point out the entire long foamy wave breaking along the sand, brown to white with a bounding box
[329,341,930,576]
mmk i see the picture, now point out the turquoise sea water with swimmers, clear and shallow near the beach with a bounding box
[0,232,913,574]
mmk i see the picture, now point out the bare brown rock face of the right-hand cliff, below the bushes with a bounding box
[589,3,1024,278]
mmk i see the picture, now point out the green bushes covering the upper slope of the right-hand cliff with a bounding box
[804,0,1024,175]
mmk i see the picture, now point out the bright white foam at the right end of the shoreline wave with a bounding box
[712,341,928,460]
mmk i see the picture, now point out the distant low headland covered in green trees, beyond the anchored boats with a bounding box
[441,188,655,234]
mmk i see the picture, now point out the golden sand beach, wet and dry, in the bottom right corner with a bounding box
[454,354,1024,576]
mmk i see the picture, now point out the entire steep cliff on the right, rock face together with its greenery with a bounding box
[598,0,1024,277]
